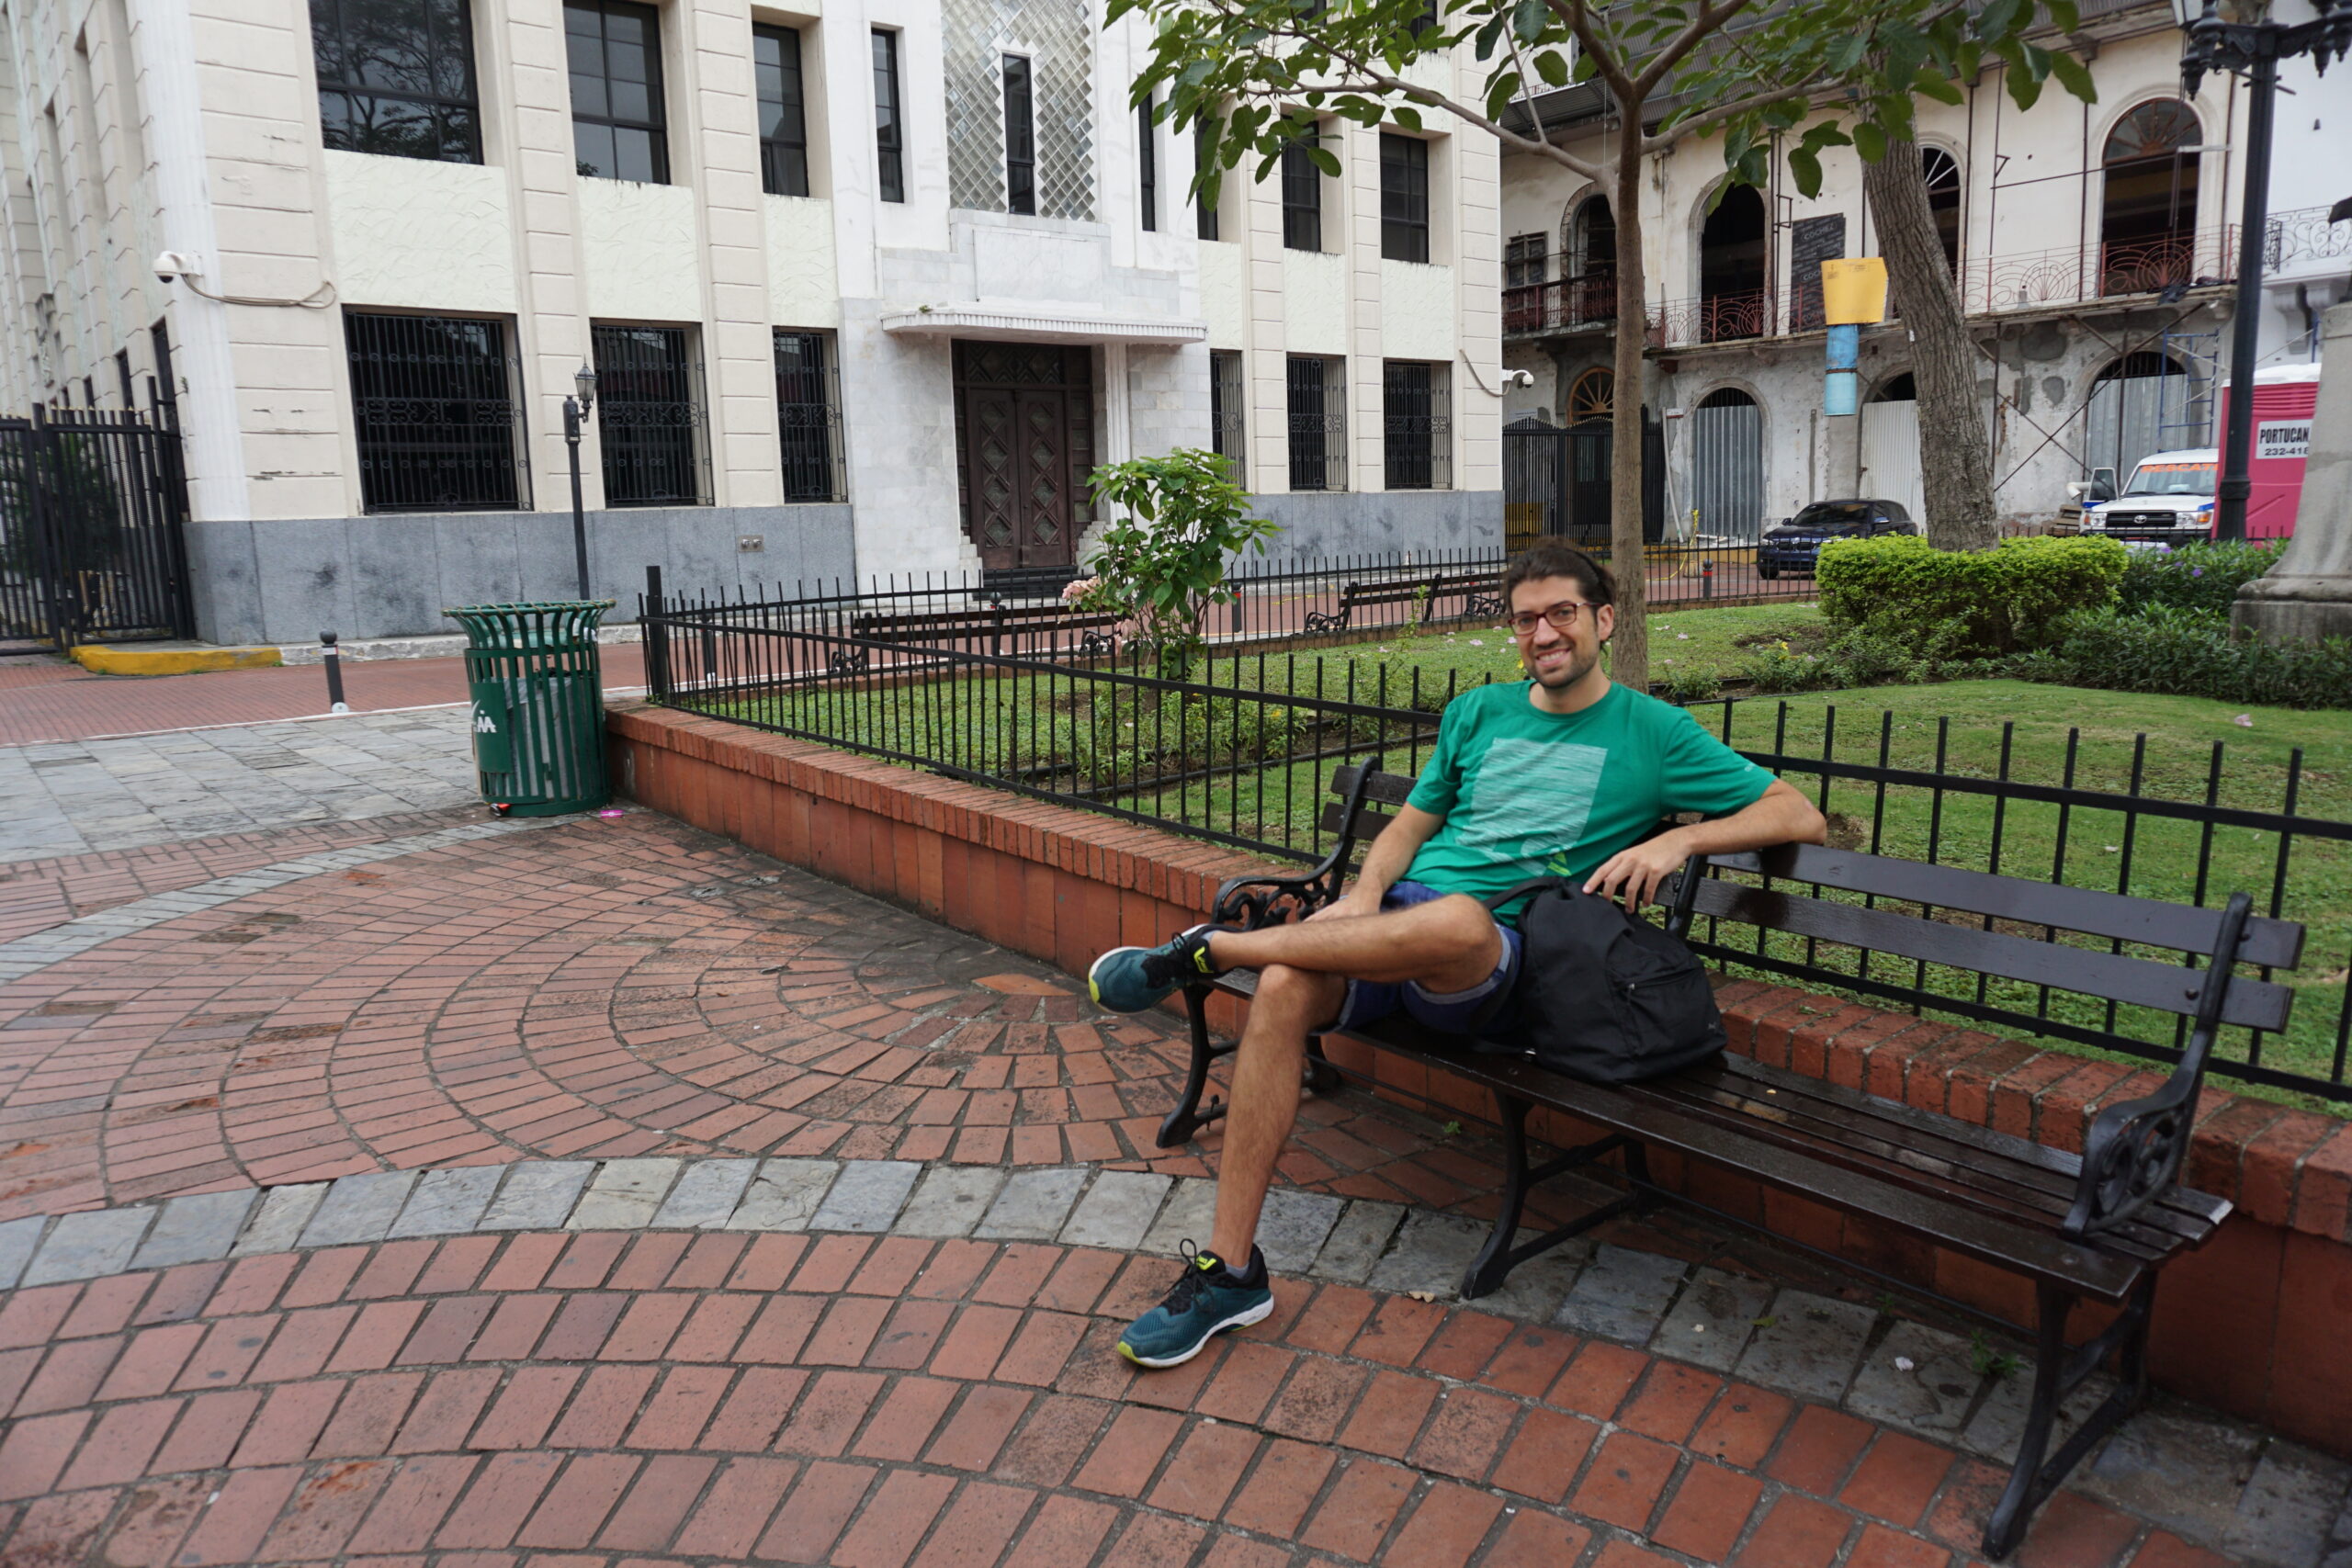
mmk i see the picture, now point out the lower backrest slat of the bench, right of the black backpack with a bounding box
[1693,877,2296,1030]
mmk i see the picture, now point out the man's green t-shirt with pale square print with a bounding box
[1404,682,1773,898]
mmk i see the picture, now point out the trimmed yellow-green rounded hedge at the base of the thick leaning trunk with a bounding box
[1815,534,2131,659]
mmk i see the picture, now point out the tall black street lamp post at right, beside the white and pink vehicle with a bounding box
[2173,0,2352,538]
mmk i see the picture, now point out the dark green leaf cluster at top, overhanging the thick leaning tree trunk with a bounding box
[1675,0,2098,197]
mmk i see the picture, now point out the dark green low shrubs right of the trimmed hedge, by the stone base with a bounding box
[2004,606,2352,707]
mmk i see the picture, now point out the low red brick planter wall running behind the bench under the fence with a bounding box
[609,705,2352,1455]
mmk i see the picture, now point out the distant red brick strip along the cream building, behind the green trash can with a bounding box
[0,642,644,745]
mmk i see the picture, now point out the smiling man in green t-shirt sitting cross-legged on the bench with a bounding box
[1087,546,1826,1366]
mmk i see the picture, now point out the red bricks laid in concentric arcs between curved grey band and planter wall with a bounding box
[0,813,1494,1218]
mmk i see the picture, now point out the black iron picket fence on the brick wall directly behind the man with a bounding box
[642,592,2352,1100]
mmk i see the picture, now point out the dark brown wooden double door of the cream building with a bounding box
[955,344,1093,571]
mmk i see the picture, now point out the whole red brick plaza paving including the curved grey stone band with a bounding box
[0,780,2352,1568]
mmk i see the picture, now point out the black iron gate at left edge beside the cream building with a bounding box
[0,404,195,651]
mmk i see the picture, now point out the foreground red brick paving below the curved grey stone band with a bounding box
[0,1232,2222,1568]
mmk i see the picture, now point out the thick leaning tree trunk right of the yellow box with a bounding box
[1863,141,1999,550]
